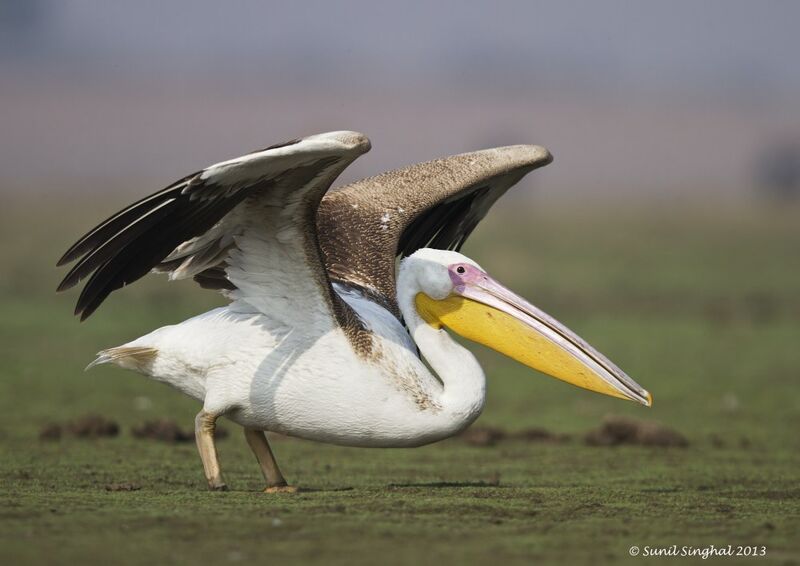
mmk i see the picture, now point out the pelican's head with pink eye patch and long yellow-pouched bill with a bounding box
[401,248,652,406]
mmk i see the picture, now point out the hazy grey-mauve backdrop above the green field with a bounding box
[0,0,800,197]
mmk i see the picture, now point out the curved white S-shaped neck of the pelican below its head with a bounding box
[397,266,486,432]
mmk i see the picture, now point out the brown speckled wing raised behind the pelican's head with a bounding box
[317,145,552,316]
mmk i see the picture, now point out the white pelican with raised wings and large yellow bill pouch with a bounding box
[58,131,652,492]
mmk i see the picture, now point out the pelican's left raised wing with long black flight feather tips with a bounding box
[58,132,370,320]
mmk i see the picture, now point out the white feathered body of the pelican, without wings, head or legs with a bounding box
[118,272,485,447]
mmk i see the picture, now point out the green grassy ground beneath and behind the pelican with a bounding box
[0,194,800,564]
